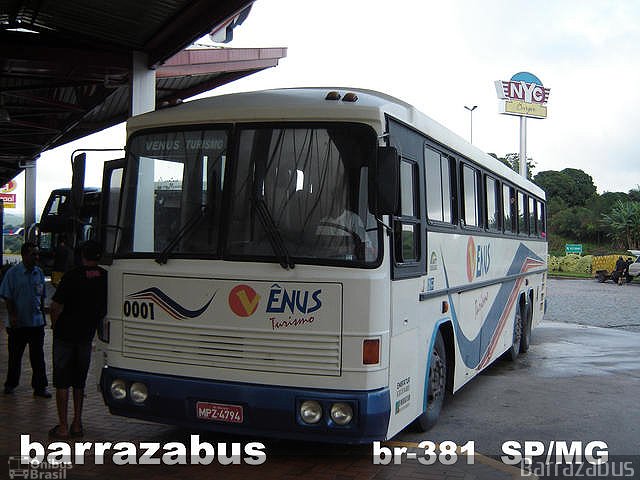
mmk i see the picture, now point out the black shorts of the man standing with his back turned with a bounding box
[53,337,91,389]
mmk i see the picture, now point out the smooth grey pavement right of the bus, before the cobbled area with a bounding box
[403,321,640,456]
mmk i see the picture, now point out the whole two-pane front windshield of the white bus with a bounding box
[117,123,381,267]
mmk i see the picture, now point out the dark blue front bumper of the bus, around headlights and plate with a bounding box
[100,367,391,443]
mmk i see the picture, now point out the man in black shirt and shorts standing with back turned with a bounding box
[49,240,107,439]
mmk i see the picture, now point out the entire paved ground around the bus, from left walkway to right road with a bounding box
[0,280,640,480]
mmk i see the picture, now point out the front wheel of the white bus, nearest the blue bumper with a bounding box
[416,331,447,432]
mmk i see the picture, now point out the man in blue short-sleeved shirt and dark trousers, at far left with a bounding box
[0,242,51,398]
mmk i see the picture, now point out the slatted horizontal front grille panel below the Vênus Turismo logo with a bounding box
[123,320,341,376]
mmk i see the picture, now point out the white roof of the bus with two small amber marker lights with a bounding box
[127,87,545,198]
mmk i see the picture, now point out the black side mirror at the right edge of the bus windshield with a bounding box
[375,147,400,216]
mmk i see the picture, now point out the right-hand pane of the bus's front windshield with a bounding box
[226,124,379,263]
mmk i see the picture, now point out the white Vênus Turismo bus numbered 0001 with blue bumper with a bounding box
[99,88,547,443]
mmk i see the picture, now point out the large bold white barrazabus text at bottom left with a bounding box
[20,435,267,465]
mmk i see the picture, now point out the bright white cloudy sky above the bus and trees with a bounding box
[6,0,640,215]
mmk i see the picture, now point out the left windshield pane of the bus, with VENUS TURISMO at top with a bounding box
[119,129,228,256]
